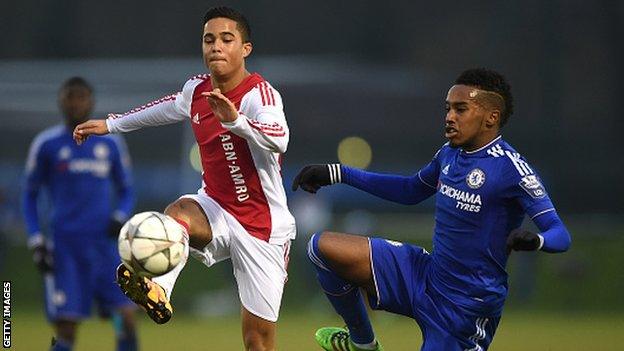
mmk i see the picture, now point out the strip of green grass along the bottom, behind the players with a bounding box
[12,309,624,351]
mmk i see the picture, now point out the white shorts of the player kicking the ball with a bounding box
[180,190,290,322]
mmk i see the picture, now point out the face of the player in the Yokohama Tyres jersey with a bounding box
[444,85,490,150]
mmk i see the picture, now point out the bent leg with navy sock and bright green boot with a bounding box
[308,232,383,351]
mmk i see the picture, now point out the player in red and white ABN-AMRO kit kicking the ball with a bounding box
[74,7,295,350]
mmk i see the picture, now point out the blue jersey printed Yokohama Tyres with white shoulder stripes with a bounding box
[418,136,554,315]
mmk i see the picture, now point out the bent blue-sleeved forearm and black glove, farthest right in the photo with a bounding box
[507,209,571,253]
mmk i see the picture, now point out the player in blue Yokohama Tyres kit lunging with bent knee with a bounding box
[293,69,570,351]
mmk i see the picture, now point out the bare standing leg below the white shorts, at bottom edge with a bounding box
[241,307,277,351]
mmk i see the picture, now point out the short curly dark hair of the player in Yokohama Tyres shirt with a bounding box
[455,68,513,127]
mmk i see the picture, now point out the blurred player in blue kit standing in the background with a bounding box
[23,77,137,351]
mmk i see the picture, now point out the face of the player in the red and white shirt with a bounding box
[202,18,251,79]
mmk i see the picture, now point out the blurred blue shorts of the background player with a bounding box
[44,238,134,322]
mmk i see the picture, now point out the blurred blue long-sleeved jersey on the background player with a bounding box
[23,125,134,240]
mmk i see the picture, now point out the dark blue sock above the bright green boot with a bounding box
[308,233,375,344]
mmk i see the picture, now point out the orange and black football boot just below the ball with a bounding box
[117,264,173,324]
